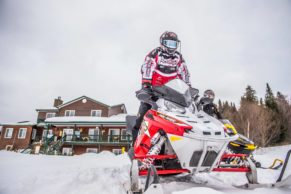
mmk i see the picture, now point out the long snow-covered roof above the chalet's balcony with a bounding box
[45,114,127,125]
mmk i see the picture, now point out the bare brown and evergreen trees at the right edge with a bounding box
[218,83,291,147]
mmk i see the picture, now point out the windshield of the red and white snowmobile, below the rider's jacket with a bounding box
[153,79,192,107]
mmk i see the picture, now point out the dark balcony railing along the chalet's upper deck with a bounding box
[63,134,132,144]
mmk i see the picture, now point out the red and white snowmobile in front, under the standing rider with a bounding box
[127,79,291,194]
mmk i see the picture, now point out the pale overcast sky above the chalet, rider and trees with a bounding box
[0,0,291,123]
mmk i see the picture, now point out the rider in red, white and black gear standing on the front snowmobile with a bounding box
[132,31,191,145]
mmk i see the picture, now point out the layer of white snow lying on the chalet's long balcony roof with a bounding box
[45,114,127,122]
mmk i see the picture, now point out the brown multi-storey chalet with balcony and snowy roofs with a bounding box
[0,96,131,155]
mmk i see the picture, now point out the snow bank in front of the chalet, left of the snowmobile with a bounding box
[0,151,130,194]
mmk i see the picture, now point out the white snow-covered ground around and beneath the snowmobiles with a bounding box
[0,145,291,194]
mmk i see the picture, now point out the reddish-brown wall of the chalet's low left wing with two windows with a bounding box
[0,125,32,150]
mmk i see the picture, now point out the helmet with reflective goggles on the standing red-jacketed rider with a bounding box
[160,31,180,54]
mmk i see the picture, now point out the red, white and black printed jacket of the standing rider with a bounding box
[141,47,190,86]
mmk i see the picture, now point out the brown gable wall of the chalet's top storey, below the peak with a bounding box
[59,99,108,117]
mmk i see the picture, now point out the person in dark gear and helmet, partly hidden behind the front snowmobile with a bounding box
[202,90,222,120]
